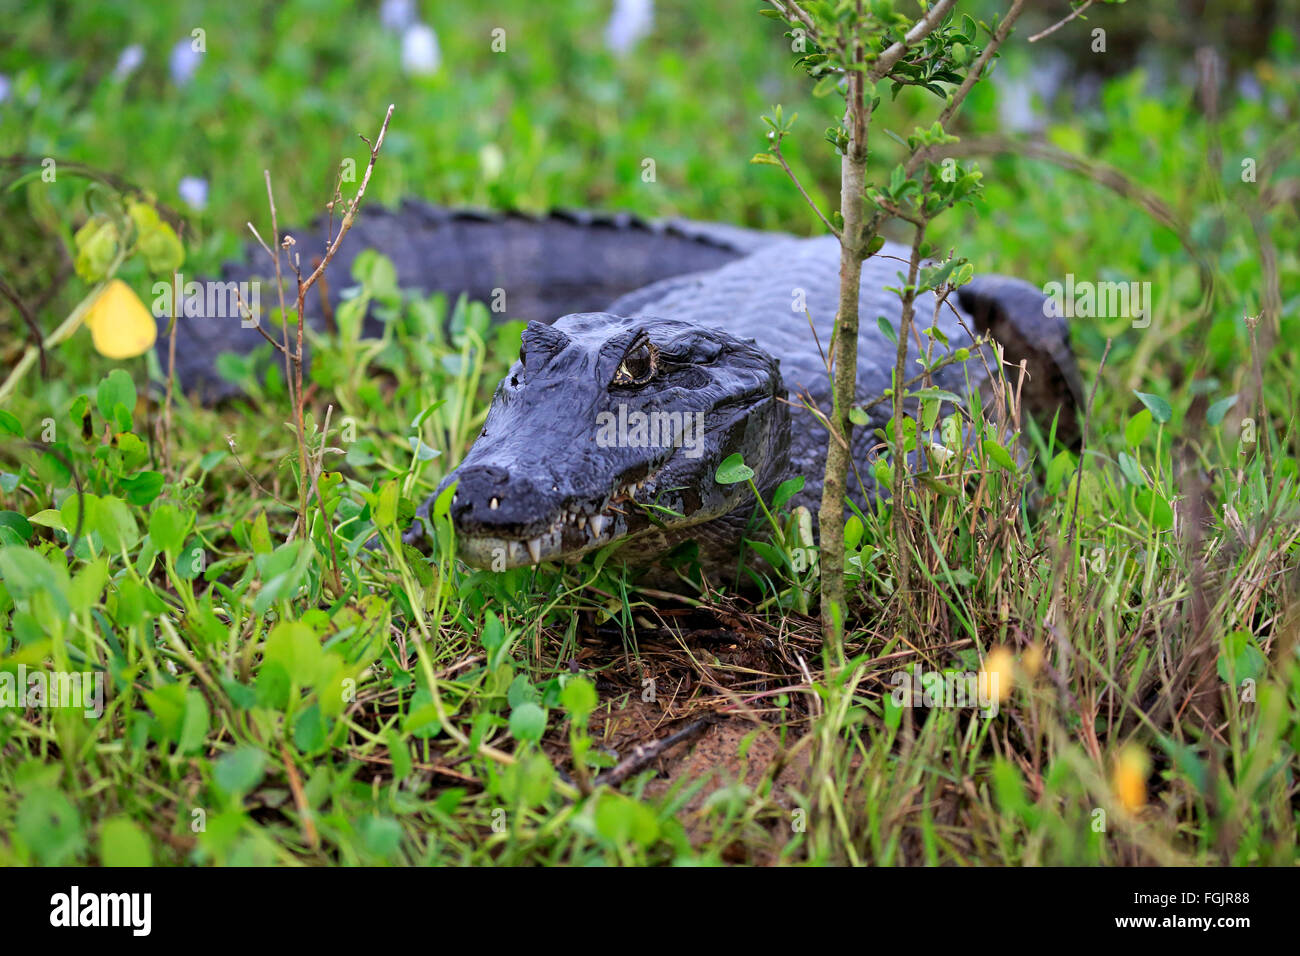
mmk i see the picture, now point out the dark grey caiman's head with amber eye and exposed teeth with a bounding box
[438,312,789,570]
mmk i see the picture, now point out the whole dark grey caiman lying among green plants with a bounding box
[159,202,1082,580]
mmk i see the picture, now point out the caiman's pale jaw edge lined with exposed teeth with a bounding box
[452,462,663,570]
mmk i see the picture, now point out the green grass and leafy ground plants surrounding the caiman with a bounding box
[0,0,1300,865]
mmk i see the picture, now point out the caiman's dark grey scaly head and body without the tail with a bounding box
[428,237,1079,572]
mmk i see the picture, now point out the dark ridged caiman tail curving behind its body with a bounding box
[157,200,785,402]
